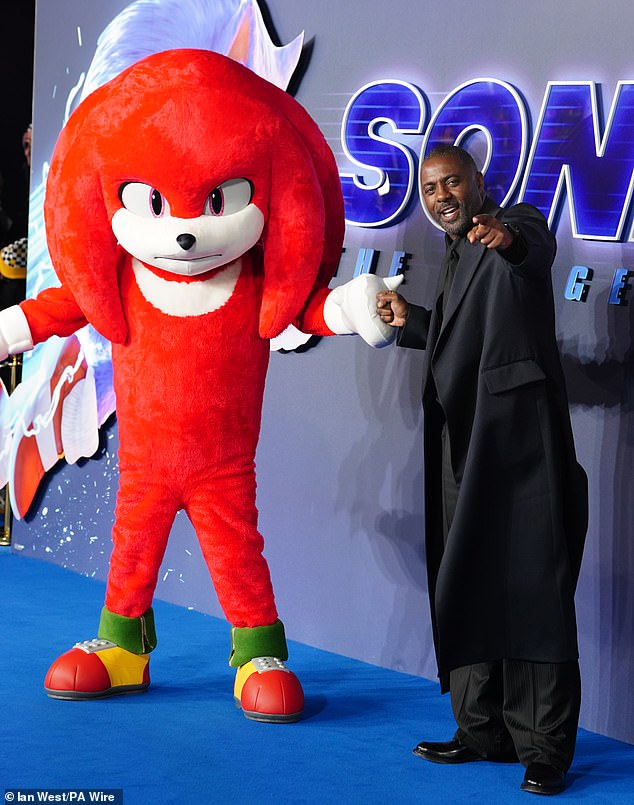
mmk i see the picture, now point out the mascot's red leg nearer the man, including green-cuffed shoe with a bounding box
[187,464,304,722]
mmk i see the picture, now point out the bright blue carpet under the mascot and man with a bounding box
[0,549,634,805]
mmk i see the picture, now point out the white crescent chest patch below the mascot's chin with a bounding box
[132,257,242,317]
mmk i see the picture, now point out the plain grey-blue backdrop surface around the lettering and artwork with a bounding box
[14,0,634,742]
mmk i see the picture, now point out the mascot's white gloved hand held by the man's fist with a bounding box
[324,274,404,348]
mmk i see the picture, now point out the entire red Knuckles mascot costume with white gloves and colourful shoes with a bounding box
[0,49,394,721]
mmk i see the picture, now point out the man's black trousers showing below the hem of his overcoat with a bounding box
[449,660,581,772]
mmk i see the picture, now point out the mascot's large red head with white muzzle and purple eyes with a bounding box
[45,49,344,342]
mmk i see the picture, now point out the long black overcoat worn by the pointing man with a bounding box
[398,198,587,689]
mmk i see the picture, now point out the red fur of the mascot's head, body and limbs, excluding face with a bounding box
[28,50,343,626]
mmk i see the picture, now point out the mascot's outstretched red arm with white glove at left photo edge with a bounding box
[0,285,88,359]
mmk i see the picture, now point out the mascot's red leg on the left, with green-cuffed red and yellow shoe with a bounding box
[44,464,177,699]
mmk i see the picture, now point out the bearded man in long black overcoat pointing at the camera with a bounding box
[377,146,587,794]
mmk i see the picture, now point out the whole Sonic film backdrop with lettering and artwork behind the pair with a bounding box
[9,0,634,741]
